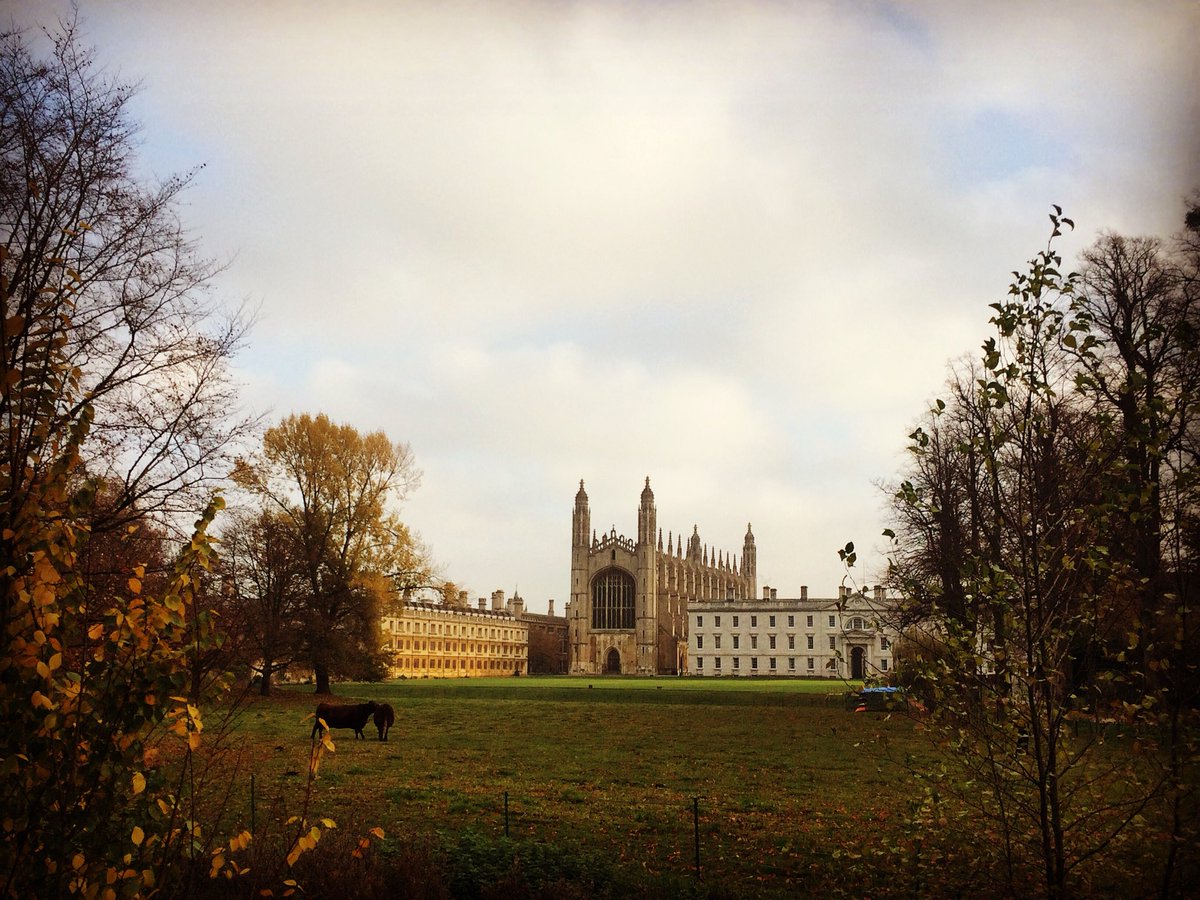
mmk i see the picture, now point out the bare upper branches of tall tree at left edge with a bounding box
[0,23,253,549]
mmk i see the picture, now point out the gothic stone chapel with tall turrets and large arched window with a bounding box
[568,478,757,674]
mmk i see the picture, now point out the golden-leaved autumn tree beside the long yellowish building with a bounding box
[236,415,420,694]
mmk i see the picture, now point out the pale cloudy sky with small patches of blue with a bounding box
[9,0,1200,613]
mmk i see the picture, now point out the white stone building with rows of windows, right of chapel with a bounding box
[686,587,896,679]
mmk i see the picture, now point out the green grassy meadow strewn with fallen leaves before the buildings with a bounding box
[196,677,1171,898]
